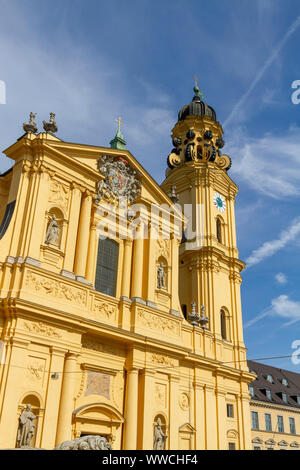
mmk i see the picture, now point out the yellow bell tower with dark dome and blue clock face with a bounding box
[162,83,247,370]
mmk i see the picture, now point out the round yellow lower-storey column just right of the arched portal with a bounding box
[124,369,139,450]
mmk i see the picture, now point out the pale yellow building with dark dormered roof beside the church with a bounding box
[248,361,300,450]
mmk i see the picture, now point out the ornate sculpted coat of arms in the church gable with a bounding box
[97,155,142,205]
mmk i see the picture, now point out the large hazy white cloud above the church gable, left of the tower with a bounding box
[0,1,176,177]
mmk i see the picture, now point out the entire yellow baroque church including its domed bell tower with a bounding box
[0,87,253,450]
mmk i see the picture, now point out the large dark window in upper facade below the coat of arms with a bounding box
[95,238,119,296]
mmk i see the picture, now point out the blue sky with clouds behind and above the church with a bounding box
[0,0,300,372]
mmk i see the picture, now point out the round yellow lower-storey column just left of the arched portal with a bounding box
[56,354,77,445]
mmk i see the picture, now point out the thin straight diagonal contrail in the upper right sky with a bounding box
[223,16,300,127]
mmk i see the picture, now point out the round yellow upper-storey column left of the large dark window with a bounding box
[75,191,92,280]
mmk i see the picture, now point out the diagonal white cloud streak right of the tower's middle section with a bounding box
[246,217,300,268]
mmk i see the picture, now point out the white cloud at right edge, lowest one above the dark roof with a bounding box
[245,295,300,328]
